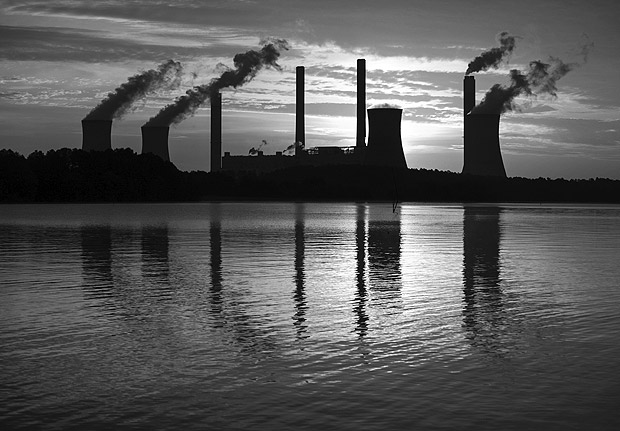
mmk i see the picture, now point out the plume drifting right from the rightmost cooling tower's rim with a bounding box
[471,57,578,114]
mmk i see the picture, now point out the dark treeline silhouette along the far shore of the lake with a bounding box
[0,148,620,203]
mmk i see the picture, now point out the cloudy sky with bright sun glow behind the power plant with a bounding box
[0,0,620,179]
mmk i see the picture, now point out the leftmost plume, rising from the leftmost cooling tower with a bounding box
[84,60,183,120]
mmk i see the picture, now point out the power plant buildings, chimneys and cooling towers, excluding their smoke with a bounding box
[82,59,506,177]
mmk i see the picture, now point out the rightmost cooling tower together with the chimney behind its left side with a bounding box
[462,76,506,177]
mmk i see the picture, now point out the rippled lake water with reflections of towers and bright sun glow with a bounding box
[0,203,620,430]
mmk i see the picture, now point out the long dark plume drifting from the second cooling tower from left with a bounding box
[145,39,289,127]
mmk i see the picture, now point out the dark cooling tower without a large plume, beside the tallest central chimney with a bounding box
[364,108,407,169]
